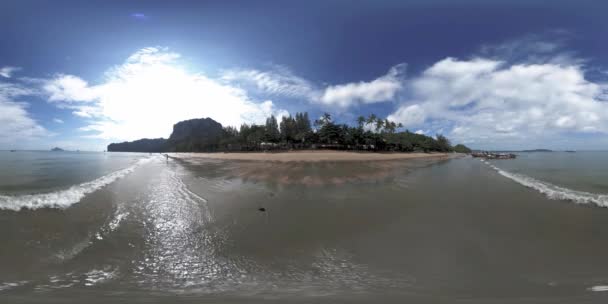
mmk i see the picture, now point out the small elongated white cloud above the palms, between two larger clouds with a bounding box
[319,64,406,107]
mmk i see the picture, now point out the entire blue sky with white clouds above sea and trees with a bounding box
[0,0,608,151]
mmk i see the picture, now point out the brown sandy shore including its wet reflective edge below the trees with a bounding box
[171,151,461,186]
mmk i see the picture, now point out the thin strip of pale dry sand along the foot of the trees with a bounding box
[169,150,460,162]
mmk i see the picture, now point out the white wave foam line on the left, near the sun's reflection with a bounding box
[0,158,150,211]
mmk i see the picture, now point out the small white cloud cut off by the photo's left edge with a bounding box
[0,82,49,144]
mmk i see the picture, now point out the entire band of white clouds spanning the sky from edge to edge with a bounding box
[0,41,608,151]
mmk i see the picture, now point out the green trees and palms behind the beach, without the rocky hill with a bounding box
[217,112,471,153]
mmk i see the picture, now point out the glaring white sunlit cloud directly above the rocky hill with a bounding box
[44,48,286,140]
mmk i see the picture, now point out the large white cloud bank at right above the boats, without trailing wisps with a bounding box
[388,58,608,148]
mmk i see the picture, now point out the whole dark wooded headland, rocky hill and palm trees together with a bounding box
[108,113,471,153]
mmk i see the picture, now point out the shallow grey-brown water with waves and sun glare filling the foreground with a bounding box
[0,152,608,303]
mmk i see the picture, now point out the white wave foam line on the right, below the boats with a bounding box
[487,163,608,207]
